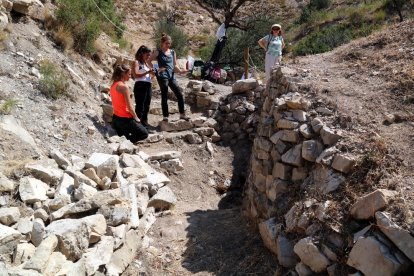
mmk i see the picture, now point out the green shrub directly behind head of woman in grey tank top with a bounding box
[152,19,188,57]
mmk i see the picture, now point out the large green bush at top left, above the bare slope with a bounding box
[56,0,125,54]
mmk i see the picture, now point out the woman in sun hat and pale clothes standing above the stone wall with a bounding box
[259,24,285,80]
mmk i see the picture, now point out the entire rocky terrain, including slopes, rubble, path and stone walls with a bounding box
[0,0,414,275]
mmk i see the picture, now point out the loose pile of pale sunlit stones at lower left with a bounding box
[0,142,183,275]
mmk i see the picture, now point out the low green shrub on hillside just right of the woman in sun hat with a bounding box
[293,25,352,56]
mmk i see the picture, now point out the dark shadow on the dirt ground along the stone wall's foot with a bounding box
[181,141,277,275]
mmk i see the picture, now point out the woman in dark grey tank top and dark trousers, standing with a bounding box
[149,33,190,122]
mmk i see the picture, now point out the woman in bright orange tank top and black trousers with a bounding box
[110,65,148,143]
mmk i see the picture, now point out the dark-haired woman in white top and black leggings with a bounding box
[132,45,154,127]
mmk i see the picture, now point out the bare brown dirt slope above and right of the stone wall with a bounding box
[294,20,414,222]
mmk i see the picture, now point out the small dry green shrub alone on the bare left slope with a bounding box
[39,60,69,99]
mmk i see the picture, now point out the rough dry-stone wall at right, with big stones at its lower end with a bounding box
[244,68,414,275]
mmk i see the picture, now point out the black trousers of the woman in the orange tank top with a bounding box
[112,115,148,143]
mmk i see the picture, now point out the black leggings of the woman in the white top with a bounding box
[134,81,152,123]
